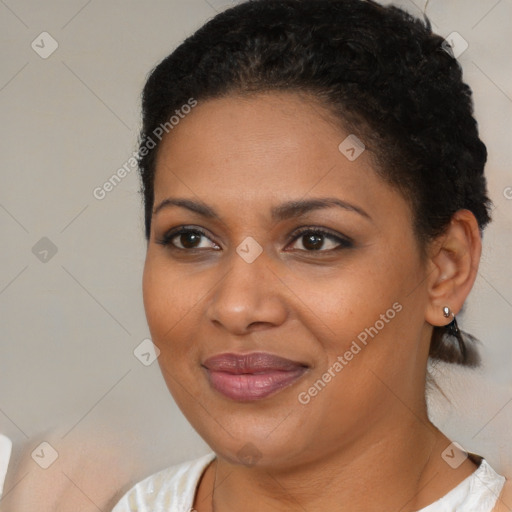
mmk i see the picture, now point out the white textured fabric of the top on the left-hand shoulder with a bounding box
[112,453,215,512]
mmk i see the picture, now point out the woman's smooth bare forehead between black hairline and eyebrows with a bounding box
[150,92,406,224]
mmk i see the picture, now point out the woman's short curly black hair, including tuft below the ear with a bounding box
[139,0,491,366]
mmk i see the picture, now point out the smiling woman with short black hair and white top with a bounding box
[114,0,511,512]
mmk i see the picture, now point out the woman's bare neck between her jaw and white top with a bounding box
[206,413,475,512]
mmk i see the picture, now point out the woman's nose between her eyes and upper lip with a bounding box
[206,245,289,335]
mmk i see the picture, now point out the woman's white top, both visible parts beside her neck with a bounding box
[112,453,505,512]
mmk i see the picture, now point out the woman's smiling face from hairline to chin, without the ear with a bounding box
[143,92,431,468]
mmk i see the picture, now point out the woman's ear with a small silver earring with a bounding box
[425,210,482,326]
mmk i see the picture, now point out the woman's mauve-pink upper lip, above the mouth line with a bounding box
[203,352,307,374]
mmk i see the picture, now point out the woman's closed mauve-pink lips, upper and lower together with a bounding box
[203,352,307,401]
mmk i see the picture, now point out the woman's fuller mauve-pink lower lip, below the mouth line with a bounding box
[206,367,306,401]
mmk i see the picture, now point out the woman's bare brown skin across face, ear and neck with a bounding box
[143,92,481,512]
